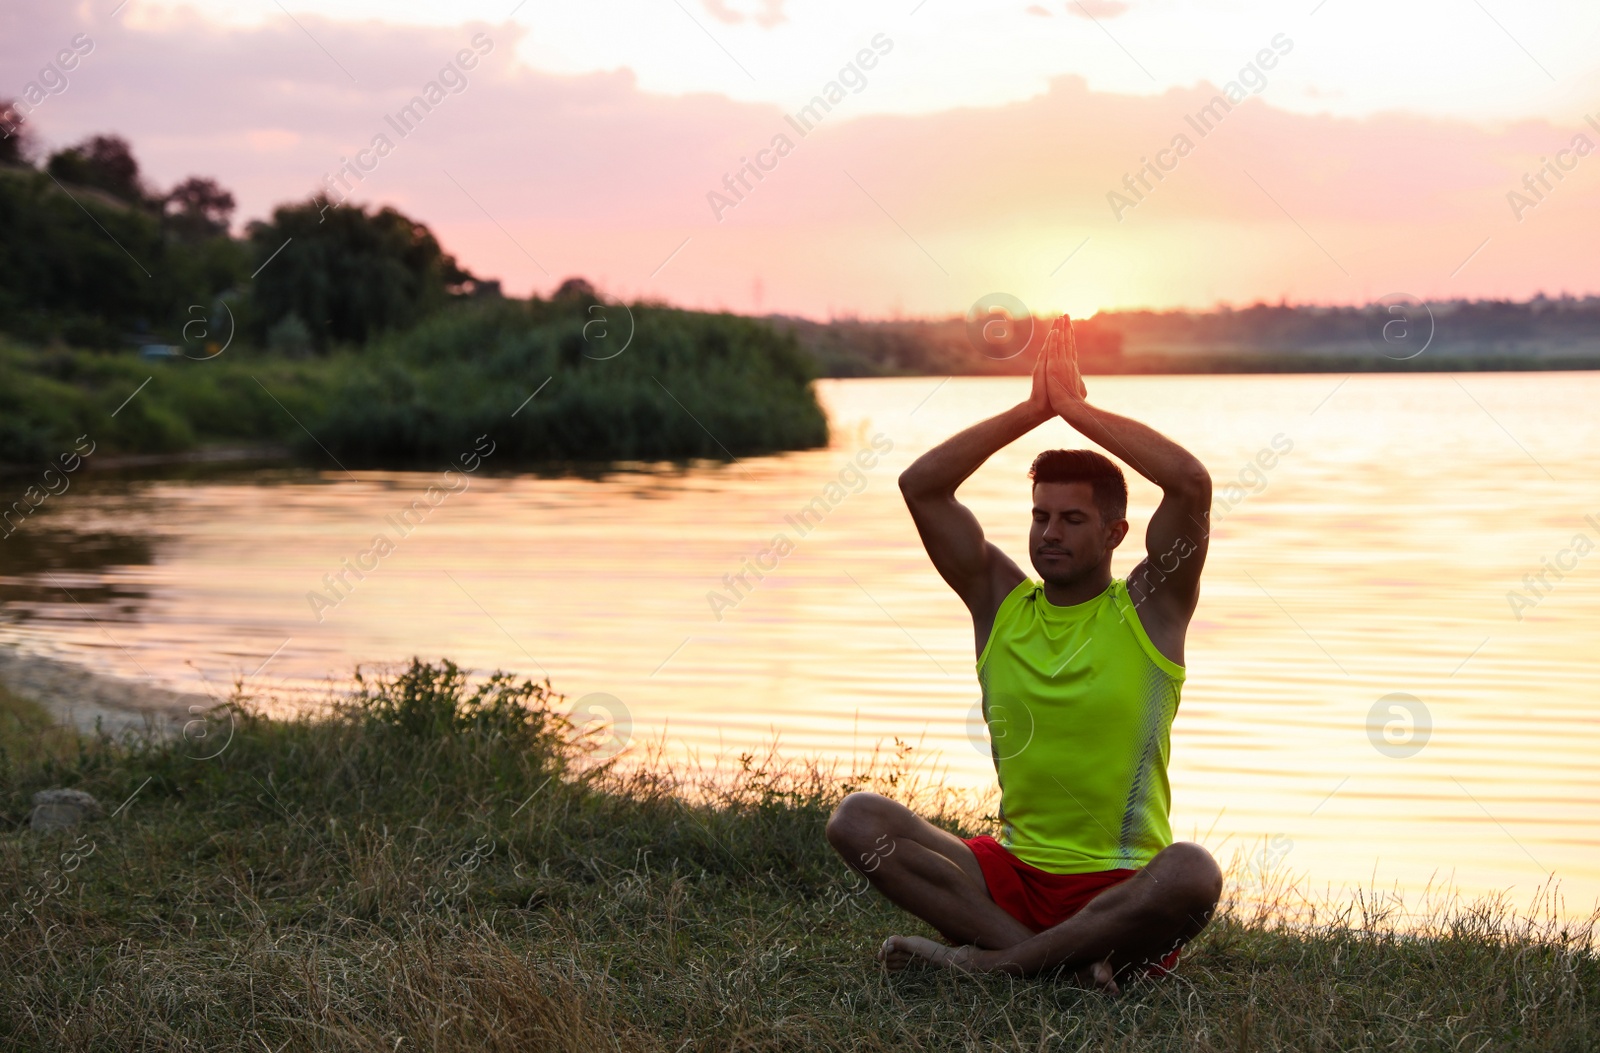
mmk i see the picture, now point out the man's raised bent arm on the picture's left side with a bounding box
[899,352,1056,650]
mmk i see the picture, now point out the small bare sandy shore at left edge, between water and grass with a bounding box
[0,647,216,733]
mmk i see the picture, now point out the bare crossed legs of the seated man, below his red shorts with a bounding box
[827,792,1222,994]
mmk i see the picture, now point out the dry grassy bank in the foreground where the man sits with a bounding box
[0,664,1600,1053]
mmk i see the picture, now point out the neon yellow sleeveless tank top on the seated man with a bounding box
[978,578,1184,874]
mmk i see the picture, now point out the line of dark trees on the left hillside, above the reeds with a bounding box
[0,101,498,355]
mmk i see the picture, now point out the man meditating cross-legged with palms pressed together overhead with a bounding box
[827,315,1222,994]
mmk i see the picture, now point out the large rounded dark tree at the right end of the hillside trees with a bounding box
[250,195,474,349]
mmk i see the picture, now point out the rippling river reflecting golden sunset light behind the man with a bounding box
[0,373,1600,914]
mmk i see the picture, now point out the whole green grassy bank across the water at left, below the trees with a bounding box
[0,301,827,469]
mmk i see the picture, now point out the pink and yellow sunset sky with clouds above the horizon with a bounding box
[0,0,1600,318]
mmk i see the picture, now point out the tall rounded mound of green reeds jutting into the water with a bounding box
[307,292,827,464]
